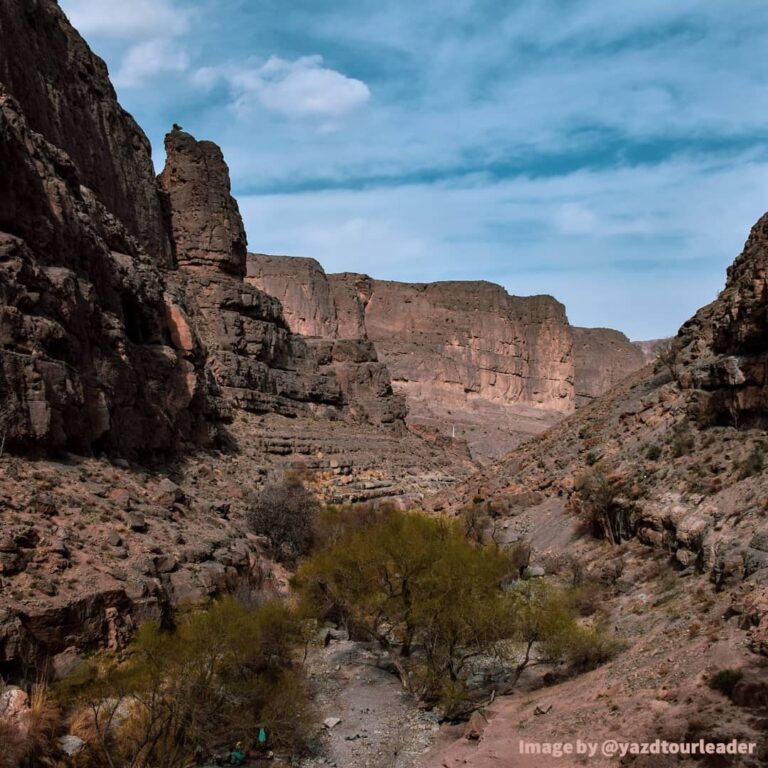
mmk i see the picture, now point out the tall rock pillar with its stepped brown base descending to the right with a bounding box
[160,130,403,426]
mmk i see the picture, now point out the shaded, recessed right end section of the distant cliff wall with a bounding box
[572,328,646,408]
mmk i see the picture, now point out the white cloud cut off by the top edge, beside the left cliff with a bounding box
[61,0,189,40]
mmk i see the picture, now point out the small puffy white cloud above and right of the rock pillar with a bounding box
[196,56,371,122]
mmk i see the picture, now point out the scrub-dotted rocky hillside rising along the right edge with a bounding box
[423,212,768,766]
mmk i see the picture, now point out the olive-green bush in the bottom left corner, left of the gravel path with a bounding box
[60,599,310,768]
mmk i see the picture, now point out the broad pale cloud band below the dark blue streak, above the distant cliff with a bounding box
[240,154,768,339]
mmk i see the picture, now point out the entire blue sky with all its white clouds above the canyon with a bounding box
[60,0,768,339]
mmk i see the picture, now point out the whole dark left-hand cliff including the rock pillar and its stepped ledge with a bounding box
[0,0,412,460]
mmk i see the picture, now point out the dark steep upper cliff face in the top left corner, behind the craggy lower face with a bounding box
[0,0,170,264]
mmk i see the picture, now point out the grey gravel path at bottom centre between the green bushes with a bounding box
[302,640,439,768]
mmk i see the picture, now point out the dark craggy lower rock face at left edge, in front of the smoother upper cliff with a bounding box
[0,84,204,458]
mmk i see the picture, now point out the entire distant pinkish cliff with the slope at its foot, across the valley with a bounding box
[248,254,644,460]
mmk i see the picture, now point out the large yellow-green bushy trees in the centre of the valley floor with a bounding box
[294,511,616,716]
